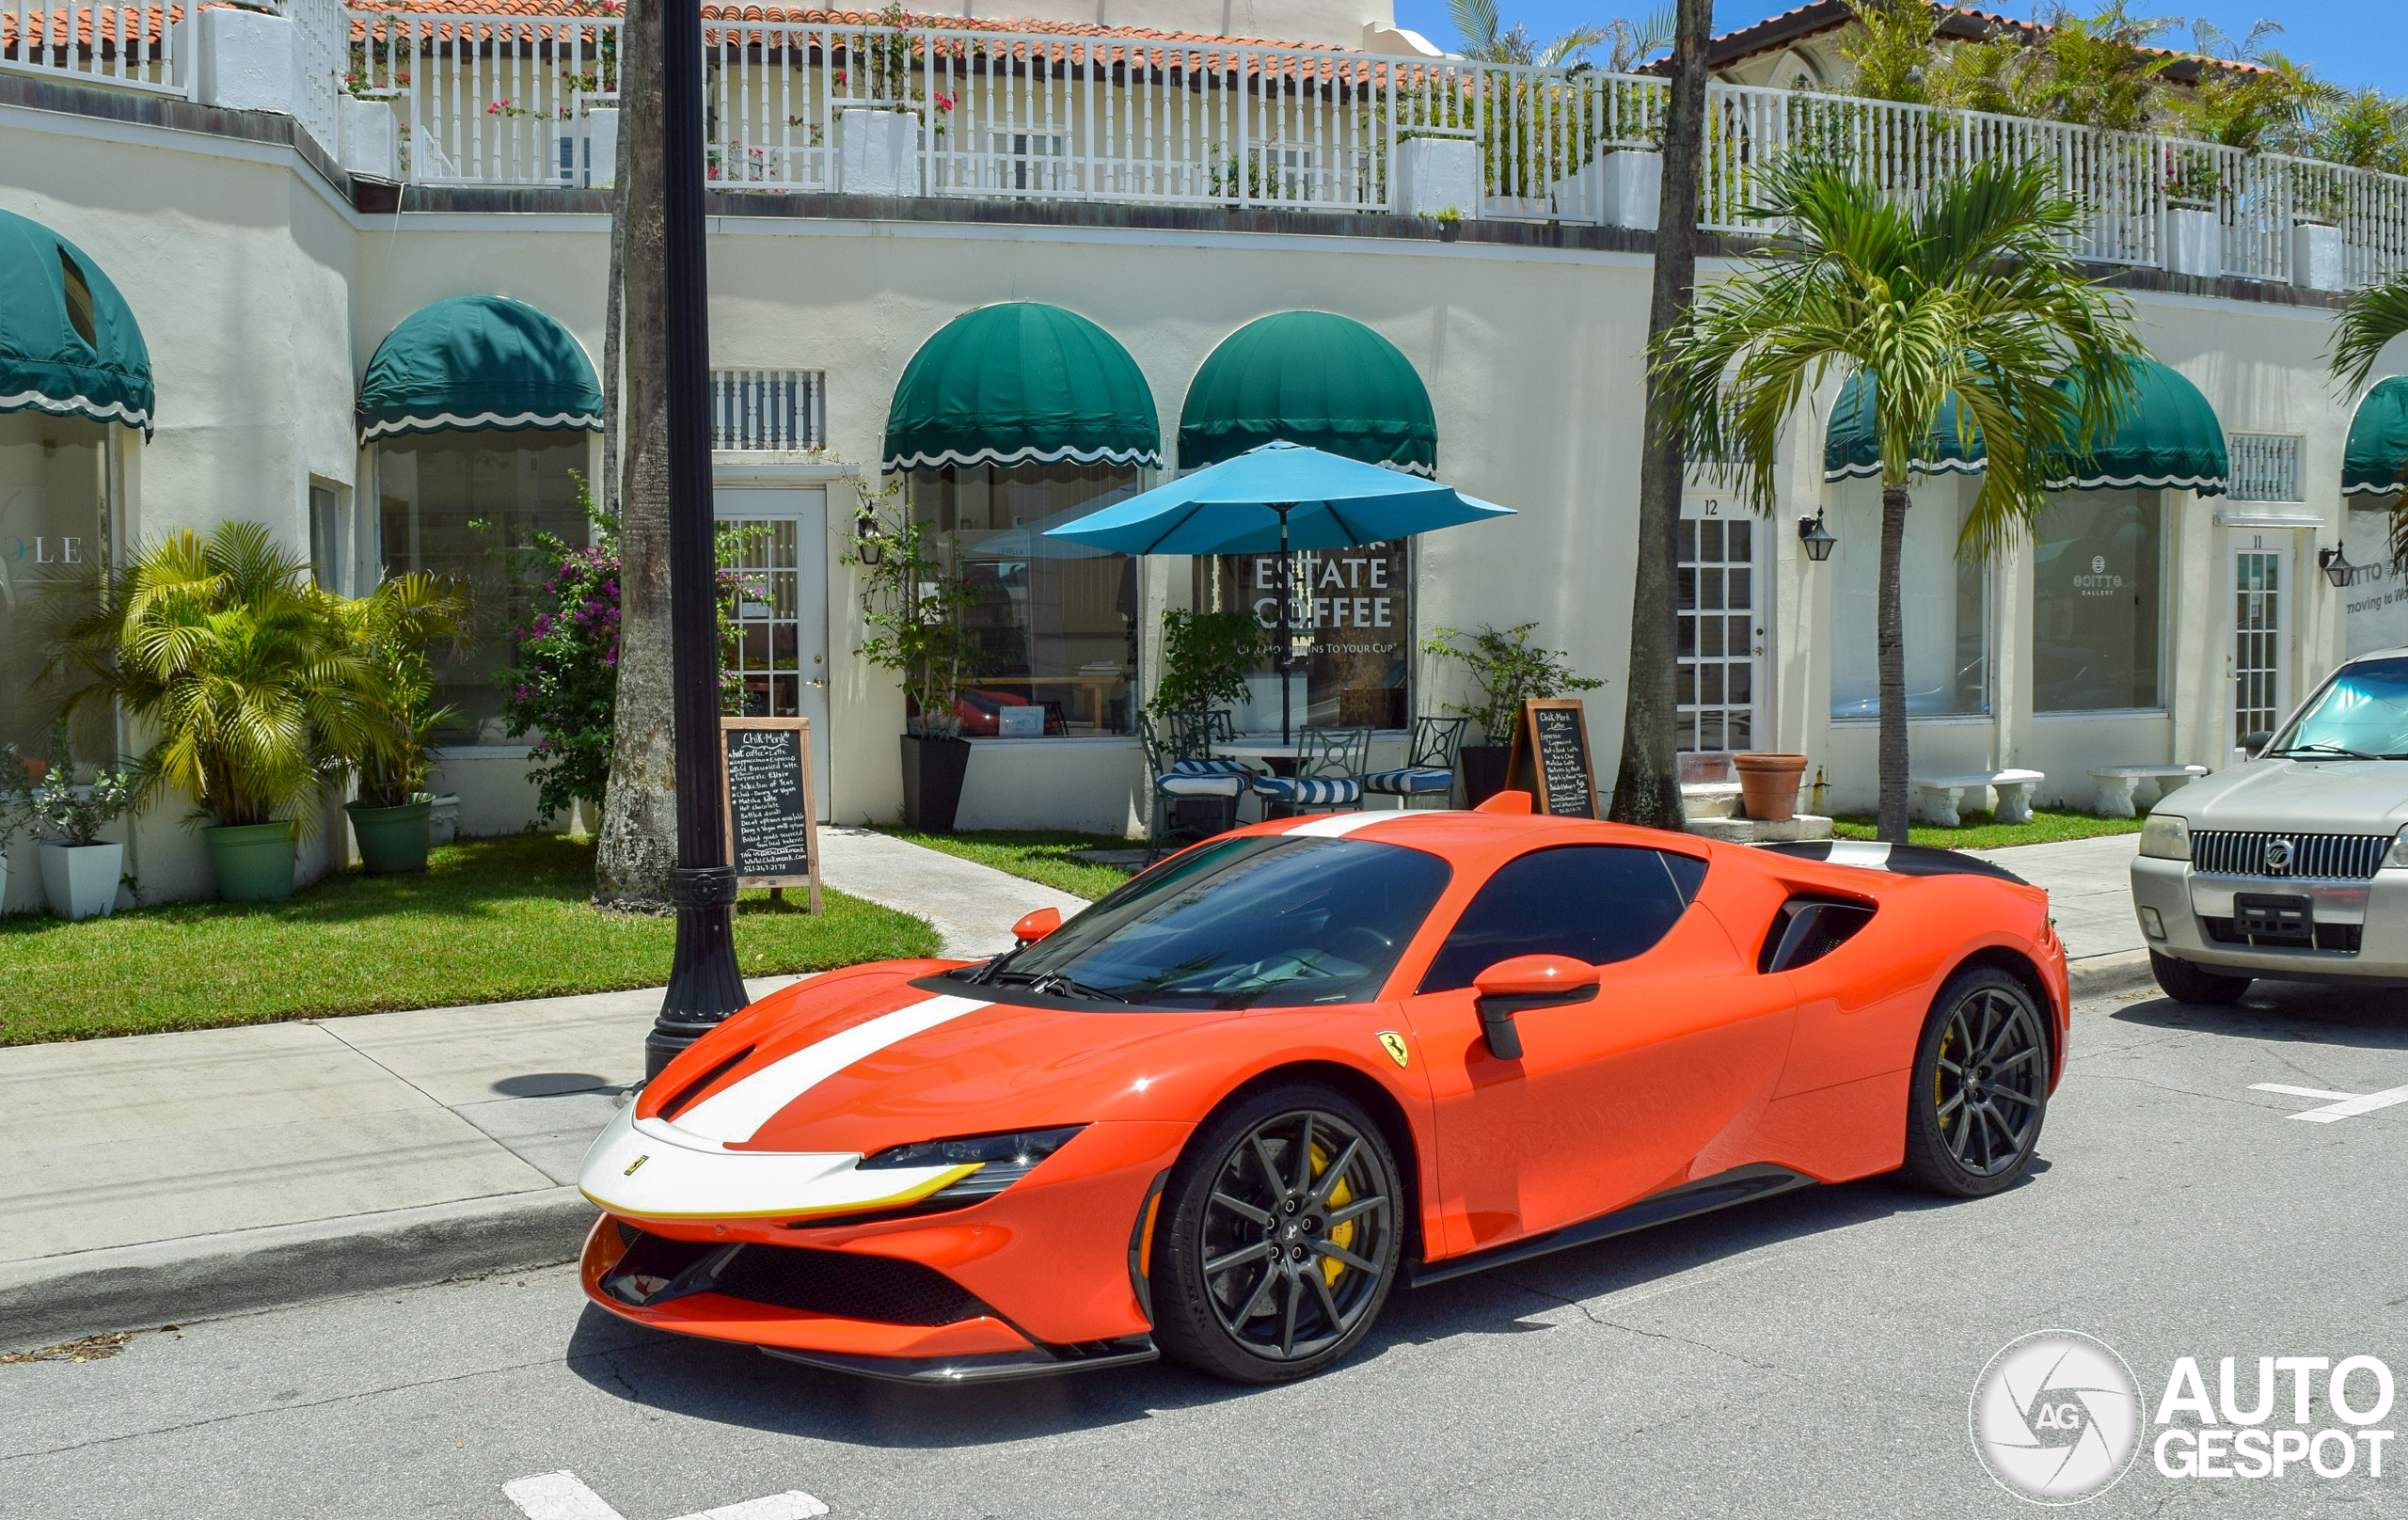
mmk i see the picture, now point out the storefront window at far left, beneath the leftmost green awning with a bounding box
[0,412,111,761]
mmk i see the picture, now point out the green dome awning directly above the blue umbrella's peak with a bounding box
[1180,310,1437,477]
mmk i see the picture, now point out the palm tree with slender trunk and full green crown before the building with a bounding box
[1655,159,2143,843]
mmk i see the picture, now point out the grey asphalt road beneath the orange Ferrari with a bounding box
[0,988,2408,1520]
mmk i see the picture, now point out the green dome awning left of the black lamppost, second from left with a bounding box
[358,296,602,443]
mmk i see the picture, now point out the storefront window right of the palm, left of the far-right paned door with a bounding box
[2033,491,2164,713]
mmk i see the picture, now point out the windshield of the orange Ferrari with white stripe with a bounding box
[960,833,1452,1007]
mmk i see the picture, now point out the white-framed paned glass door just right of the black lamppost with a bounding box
[713,484,831,819]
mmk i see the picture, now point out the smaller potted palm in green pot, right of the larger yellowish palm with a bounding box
[342,574,467,877]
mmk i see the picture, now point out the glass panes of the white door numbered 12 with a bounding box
[1673,497,1765,752]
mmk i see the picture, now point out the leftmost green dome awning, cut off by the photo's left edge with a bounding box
[0,212,151,436]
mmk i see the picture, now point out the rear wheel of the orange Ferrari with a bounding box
[1905,966,2050,1197]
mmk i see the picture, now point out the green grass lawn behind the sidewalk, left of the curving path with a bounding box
[0,833,937,1045]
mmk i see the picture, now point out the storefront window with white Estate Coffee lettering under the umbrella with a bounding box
[1195,542,1414,733]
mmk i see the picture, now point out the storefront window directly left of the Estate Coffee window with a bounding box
[908,465,1144,737]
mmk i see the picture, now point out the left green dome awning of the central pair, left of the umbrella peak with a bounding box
[884,301,1163,469]
